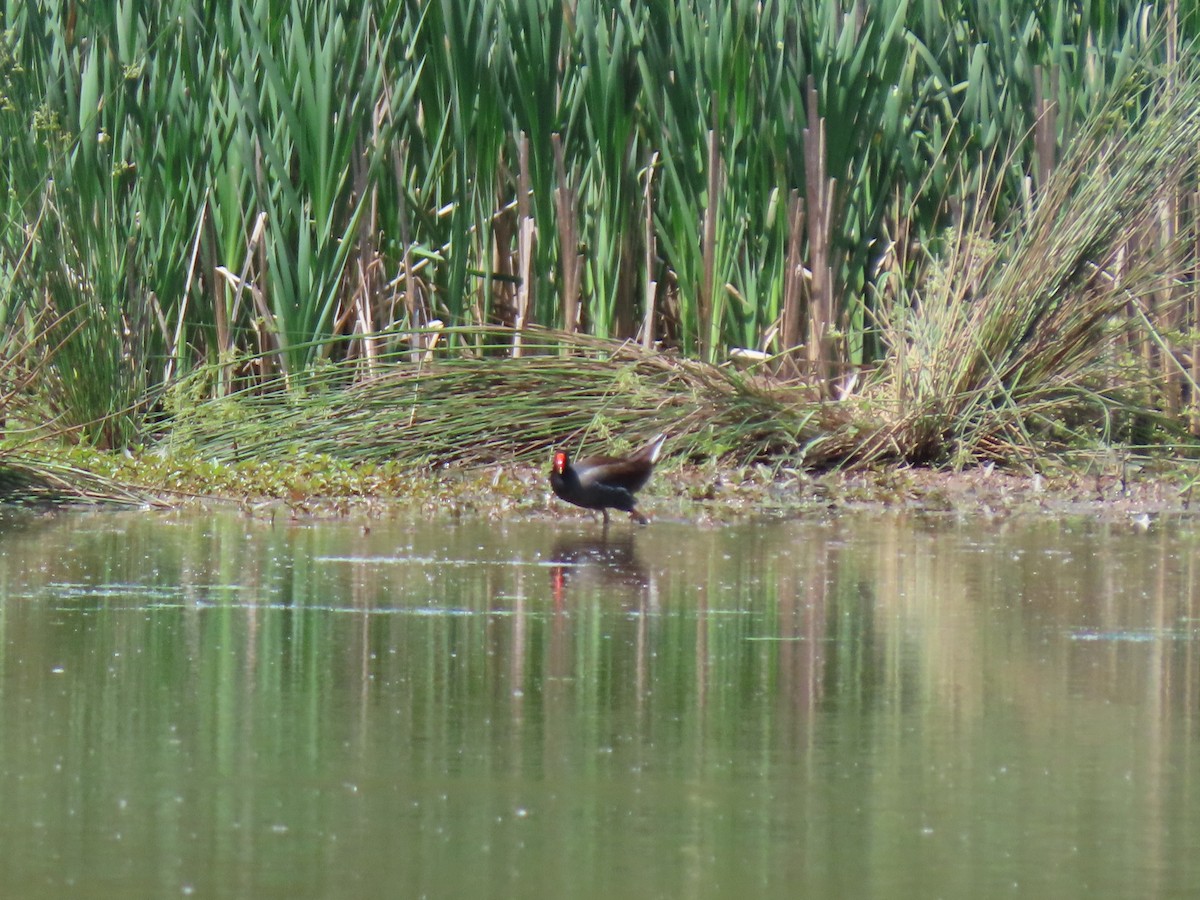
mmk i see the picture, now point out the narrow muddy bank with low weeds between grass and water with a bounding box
[12,449,1200,527]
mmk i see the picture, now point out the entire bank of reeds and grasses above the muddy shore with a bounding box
[0,0,1200,487]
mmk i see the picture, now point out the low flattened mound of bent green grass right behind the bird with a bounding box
[168,329,841,467]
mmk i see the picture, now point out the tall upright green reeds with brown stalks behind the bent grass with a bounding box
[0,0,1196,458]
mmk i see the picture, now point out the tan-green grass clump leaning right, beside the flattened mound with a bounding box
[859,50,1200,462]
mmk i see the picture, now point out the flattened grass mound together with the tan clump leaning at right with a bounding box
[170,36,1200,482]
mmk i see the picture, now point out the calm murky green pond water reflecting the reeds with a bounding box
[0,512,1200,899]
